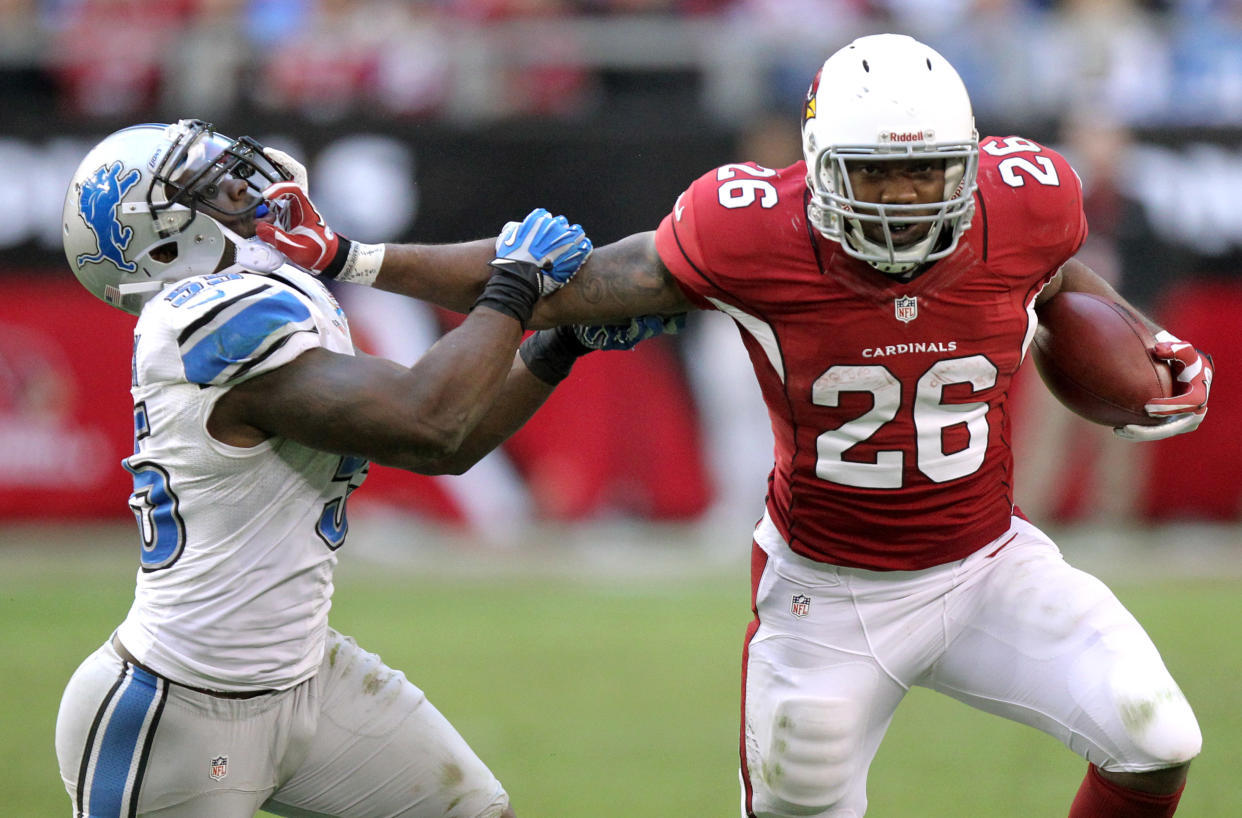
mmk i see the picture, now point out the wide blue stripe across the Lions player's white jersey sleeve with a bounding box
[181,292,314,384]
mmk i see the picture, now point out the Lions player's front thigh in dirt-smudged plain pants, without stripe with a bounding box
[263,631,508,818]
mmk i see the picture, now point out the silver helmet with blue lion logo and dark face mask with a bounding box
[62,119,289,315]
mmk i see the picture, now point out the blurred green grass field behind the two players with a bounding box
[7,521,1242,818]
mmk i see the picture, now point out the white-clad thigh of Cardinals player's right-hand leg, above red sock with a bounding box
[920,523,1201,772]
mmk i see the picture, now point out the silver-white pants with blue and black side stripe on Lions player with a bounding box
[56,629,508,818]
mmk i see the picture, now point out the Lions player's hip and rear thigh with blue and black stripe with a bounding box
[56,644,282,818]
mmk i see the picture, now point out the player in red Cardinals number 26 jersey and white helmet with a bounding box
[262,35,1211,818]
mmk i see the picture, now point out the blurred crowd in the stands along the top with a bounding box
[0,0,1242,125]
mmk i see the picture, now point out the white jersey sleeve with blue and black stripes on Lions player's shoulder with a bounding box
[139,274,324,386]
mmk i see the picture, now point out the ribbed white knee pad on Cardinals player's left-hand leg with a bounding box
[759,698,859,814]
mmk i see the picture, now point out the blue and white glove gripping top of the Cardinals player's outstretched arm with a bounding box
[492,207,594,295]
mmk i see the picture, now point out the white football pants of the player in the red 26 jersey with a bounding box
[741,516,1202,818]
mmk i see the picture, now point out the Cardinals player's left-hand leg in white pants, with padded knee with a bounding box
[743,543,905,818]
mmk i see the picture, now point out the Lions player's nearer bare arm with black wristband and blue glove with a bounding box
[209,211,590,473]
